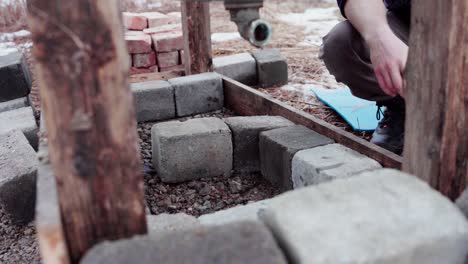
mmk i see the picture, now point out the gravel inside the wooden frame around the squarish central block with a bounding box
[138,111,279,216]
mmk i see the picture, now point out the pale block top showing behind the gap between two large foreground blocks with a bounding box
[198,200,270,225]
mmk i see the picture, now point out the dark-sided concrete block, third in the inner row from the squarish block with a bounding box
[260,126,334,190]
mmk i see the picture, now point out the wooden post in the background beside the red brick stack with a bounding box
[181,0,213,75]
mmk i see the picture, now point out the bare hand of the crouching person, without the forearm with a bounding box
[367,28,408,96]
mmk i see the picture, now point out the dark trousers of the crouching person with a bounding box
[320,12,409,102]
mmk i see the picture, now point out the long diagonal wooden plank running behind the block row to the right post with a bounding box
[223,77,402,169]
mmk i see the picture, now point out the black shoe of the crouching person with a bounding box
[371,96,406,155]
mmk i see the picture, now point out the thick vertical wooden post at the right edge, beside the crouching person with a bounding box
[403,0,468,199]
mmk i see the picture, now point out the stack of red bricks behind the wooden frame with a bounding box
[123,12,184,74]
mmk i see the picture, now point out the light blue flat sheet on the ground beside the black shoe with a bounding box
[312,88,379,131]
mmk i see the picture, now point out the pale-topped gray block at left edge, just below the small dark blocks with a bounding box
[0,107,39,149]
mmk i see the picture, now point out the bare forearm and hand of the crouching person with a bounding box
[344,0,408,96]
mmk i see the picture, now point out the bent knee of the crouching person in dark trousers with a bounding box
[320,21,357,80]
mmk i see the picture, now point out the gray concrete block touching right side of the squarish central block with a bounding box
[224,116,294,173]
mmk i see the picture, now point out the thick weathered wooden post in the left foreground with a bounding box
[28,0,146,263]
